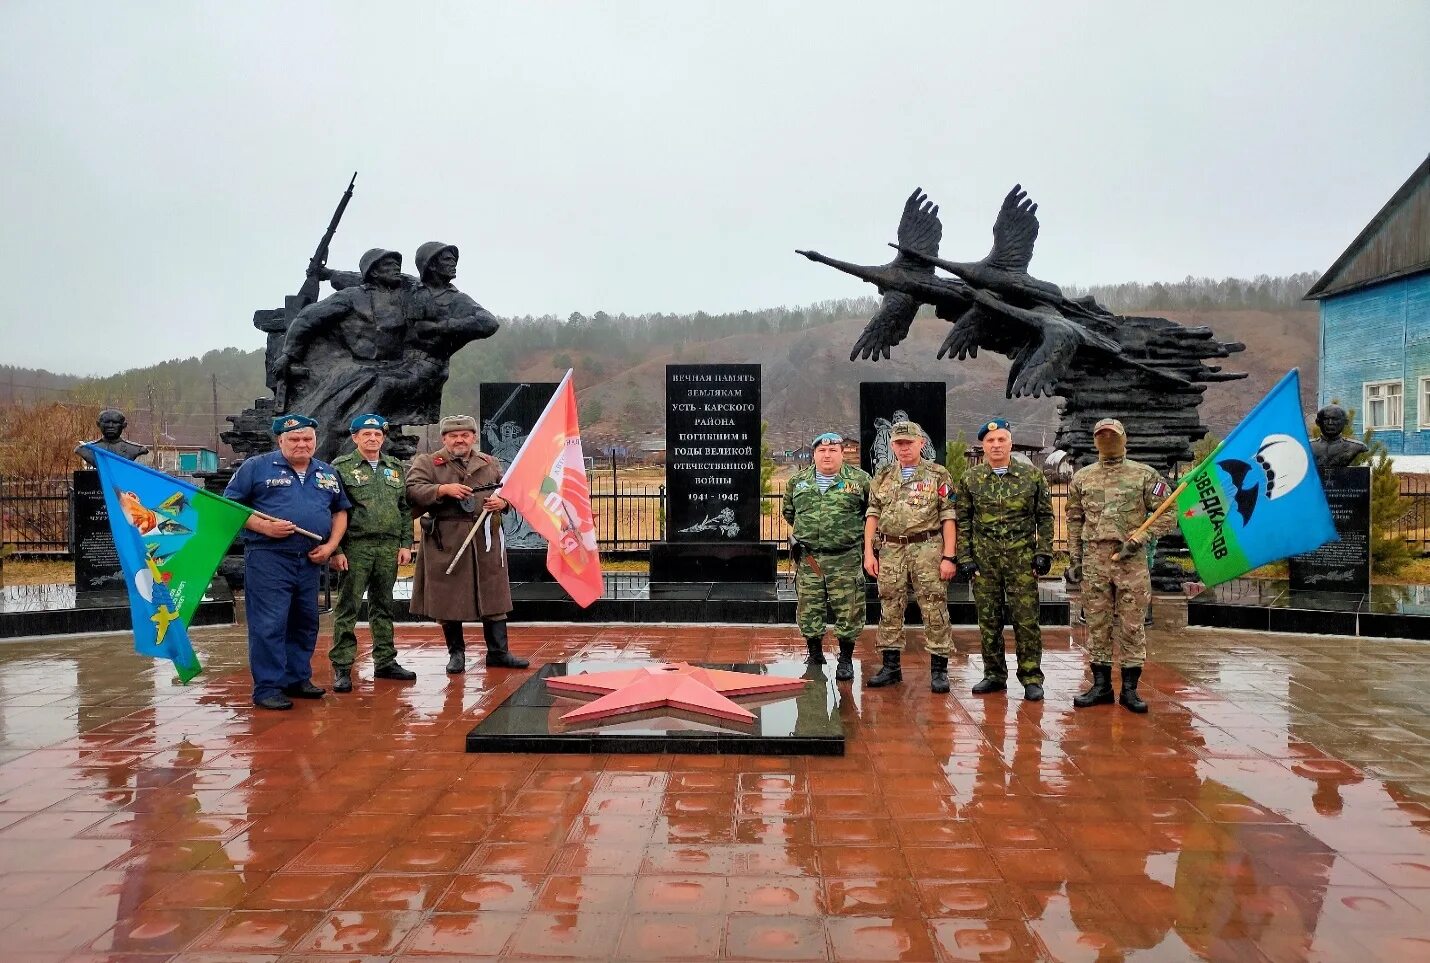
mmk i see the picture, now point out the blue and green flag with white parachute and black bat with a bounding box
[1177,368,1336,585]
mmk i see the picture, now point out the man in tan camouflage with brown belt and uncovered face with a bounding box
[864,421,957,693]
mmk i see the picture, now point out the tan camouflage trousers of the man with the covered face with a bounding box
[1083,542,1153,665]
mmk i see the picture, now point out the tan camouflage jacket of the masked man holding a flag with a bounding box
[1067,458,1177,558]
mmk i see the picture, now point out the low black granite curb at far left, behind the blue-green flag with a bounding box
[0,581,235,638]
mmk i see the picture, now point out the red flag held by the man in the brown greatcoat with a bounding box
[498,371,605,608]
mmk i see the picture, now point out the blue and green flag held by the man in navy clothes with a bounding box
[89,445,253,683]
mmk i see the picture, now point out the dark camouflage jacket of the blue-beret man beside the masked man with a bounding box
[954,461,1052,565]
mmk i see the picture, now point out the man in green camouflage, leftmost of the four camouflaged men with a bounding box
[784,432,869,683]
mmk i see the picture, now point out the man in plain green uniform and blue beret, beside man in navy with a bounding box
[327,414,418,693]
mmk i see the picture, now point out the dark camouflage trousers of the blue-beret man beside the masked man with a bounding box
[972,552,1042,685]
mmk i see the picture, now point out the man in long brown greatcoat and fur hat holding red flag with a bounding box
[408,415,528,674]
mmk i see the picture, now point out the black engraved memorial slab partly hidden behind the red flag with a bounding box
[478,381,561,582]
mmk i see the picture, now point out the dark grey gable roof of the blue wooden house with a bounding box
[1306,155,1430,300]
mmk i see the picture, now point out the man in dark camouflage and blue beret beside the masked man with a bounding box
[954,418,1052,703]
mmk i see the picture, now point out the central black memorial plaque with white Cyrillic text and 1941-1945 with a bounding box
[665,365,759,544]
